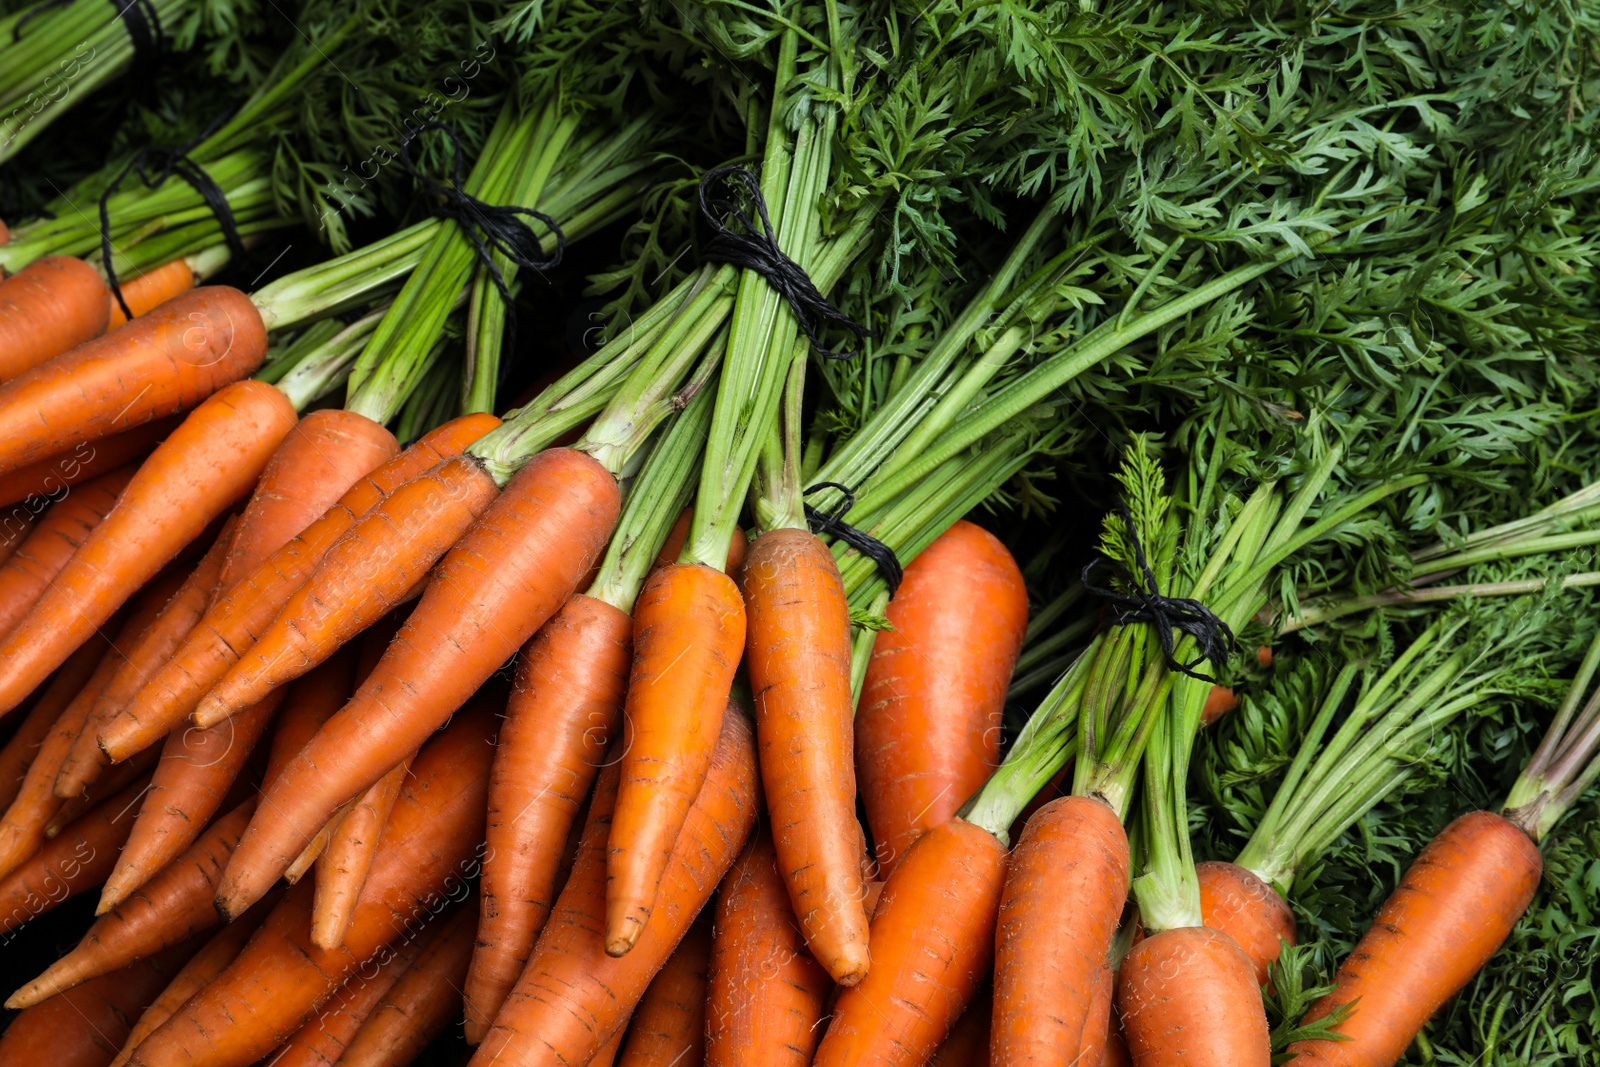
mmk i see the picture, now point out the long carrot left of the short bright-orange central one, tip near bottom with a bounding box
[466,593,634,1045]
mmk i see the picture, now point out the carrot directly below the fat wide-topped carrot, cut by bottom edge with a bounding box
[816,819,1006,1067]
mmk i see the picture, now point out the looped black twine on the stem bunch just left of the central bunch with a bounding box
[395,122,566,363]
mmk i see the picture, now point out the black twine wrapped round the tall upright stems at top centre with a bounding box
[699,163,877,360]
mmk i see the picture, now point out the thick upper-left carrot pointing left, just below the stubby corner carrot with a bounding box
[0,286,268,474]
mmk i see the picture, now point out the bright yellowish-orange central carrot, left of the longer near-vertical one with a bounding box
[605,563,746,955]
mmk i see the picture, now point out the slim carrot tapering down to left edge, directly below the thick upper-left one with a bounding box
[0,379,294,710]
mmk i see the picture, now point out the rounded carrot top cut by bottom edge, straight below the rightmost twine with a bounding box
[1117,926,1272,1067]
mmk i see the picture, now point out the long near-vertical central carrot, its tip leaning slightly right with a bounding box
[741,530,869,985]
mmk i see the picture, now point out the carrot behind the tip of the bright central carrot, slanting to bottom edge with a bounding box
[470,707,758,1067]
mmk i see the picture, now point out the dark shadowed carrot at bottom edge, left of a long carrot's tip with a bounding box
[339,901,476,1067]
